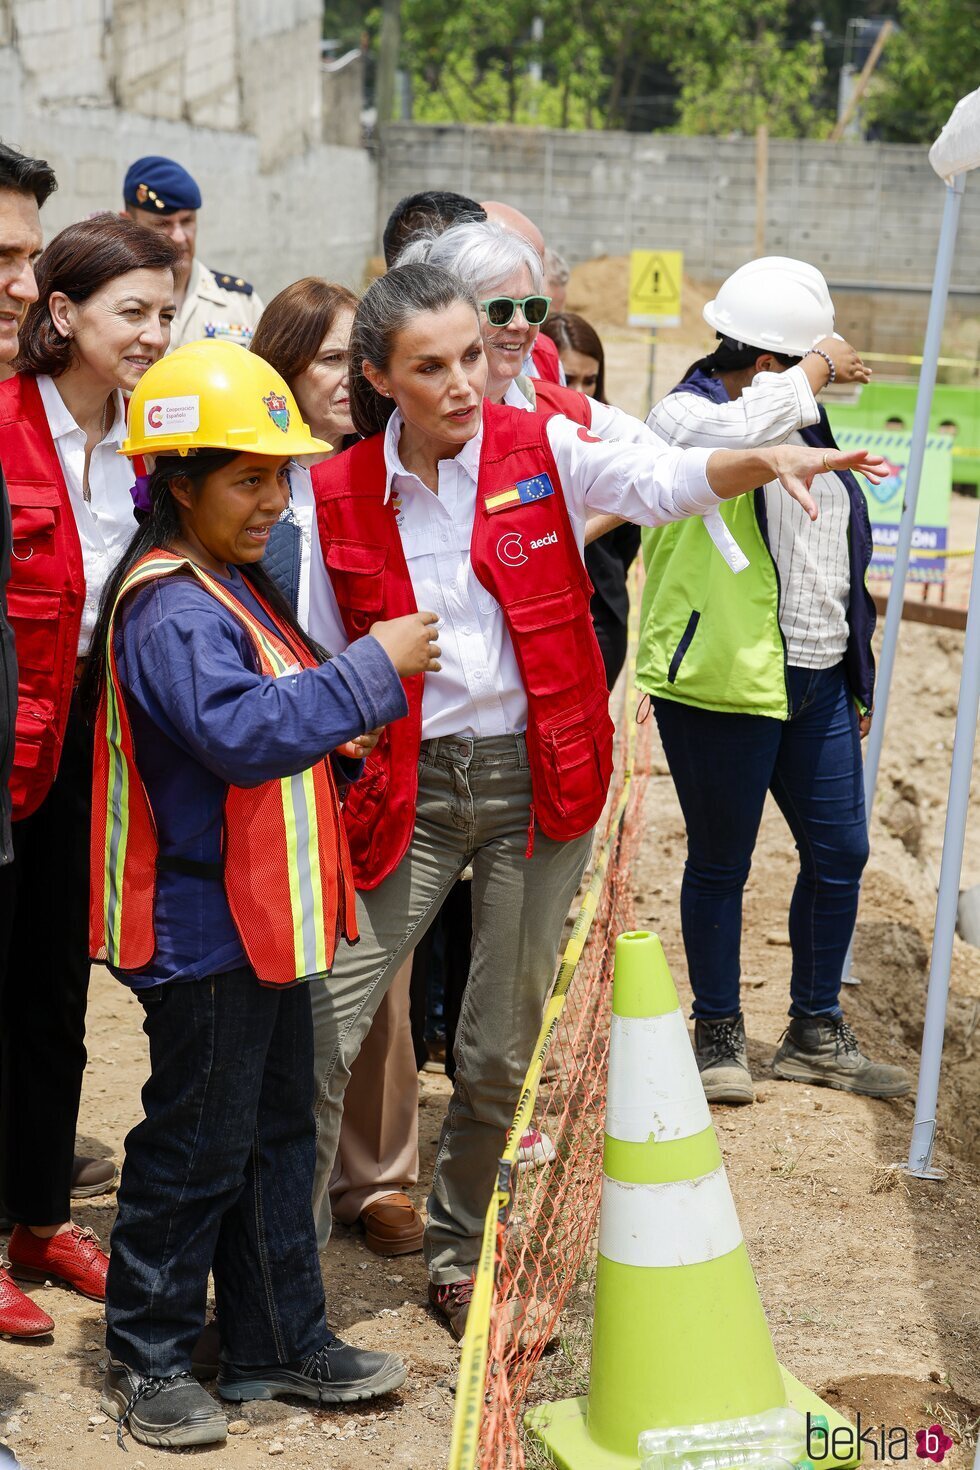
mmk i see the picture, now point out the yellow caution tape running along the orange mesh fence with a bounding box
[448,573,639,1470]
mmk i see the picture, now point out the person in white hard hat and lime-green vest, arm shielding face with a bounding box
[636,257,909,1103]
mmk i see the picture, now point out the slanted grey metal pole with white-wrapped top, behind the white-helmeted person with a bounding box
[843,173,965,983]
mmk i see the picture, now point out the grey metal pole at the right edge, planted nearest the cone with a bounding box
[908,519,980,1179]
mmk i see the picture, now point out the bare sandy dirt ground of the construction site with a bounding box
[0,262,980,1470]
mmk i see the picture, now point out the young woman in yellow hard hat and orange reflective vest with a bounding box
[82,341,439,1448]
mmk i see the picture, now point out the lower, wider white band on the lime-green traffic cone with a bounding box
[599,1164,742,1266]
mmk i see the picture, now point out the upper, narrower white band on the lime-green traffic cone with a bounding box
[605,1010,711,1144]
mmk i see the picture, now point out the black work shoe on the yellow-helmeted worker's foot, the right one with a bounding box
[217,1338,408,1404]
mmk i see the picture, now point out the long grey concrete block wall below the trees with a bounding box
[379,123,980,285]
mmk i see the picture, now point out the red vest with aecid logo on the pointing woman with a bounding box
[313,403,613,888]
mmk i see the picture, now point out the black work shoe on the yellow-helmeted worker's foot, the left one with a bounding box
[98,1358,228,1449]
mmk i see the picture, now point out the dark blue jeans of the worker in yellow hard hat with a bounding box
[106,969,328,1377]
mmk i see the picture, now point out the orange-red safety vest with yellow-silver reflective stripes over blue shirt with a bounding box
[90,551,357,985]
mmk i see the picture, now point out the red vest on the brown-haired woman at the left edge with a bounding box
[0,373,84,819]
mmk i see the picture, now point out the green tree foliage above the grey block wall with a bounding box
[325,0,963,143]
